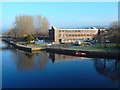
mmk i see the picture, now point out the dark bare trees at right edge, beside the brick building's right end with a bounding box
[94,21,120,47]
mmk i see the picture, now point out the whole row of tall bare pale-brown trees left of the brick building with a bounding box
[5,15,50,37]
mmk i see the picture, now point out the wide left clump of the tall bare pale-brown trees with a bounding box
[15,15,34,36]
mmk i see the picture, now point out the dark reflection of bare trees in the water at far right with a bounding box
[94,59,120,81]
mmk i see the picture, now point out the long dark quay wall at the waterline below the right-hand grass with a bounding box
[46,48,120,59]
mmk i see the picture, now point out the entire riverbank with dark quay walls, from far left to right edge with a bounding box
[2,39,120,58]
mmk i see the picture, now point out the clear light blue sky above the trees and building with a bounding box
[0,2,118,32]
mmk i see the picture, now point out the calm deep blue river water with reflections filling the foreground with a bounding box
[0,42,120,88]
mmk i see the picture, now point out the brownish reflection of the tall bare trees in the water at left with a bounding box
[12,50,48,71]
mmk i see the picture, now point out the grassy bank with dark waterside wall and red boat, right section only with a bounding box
[47,44,120,58]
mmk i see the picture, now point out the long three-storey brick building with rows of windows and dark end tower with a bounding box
[49,27,105,43]
